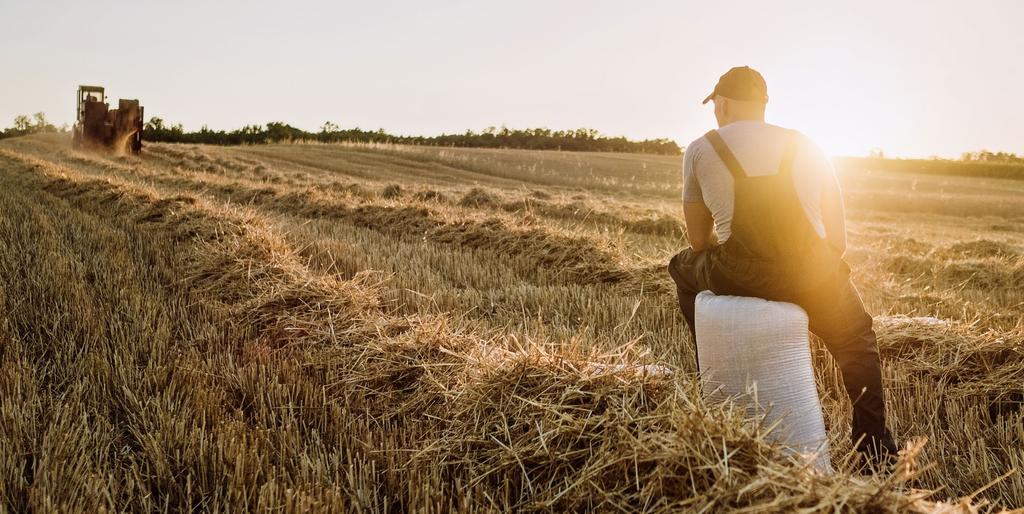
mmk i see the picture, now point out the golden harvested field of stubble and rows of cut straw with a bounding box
[0,135,1024,512]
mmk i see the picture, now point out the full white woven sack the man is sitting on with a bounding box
[694,291,831,472]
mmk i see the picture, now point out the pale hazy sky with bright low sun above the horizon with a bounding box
[0,0,1024,157]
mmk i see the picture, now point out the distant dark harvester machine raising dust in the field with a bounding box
[72,86,142,155]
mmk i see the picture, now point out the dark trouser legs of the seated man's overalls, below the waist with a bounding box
[669,249,898,454]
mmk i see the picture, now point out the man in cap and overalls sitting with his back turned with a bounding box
[669,67,898,464]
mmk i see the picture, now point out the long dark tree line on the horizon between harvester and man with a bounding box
[143,118,682,156]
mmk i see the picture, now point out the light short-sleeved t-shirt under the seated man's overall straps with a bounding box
[683,121,839,243]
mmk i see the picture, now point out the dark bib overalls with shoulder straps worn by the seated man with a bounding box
[669,130,897,455]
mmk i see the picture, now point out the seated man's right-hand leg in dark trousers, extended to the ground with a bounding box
[799,276,898,456]
